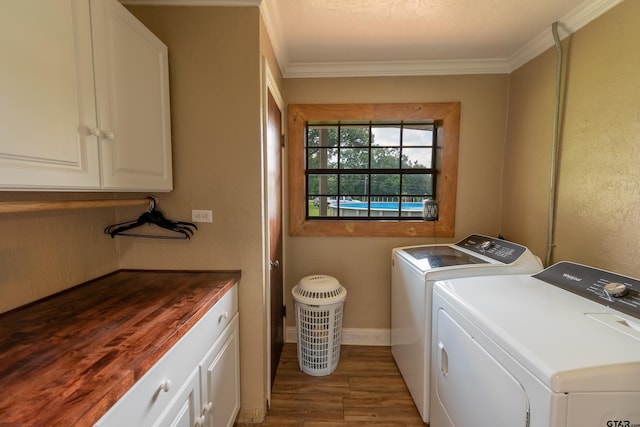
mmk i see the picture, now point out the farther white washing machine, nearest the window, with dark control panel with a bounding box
[391,234,542,422]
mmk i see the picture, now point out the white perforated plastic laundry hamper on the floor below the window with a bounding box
[291,274,347,376]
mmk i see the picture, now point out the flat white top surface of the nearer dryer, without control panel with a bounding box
[434,275,640,393]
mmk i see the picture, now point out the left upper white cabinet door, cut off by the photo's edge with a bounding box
[0,0,100,190]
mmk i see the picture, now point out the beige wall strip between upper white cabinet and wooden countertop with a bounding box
[0,191,119,313]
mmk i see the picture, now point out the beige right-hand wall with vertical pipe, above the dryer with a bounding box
[502,0,640,277]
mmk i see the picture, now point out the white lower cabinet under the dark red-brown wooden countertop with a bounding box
[95,285,240,427]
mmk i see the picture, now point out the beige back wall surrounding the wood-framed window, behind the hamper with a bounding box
[284,75,509,329]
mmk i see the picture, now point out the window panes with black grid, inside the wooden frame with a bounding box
[304,121,442,220]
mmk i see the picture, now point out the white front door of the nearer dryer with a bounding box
[431,308,529,427]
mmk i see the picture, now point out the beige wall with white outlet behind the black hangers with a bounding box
[125,7,267,419]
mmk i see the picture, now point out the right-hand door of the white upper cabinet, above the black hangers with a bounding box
[91,0,173,191]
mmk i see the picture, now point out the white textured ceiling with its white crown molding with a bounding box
[121,0,623,77]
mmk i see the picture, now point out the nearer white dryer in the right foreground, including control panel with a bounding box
[431,262,640,427]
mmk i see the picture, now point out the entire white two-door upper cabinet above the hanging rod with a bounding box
[0,0,172,191]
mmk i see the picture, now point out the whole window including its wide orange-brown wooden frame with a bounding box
[288,103,460,236]
